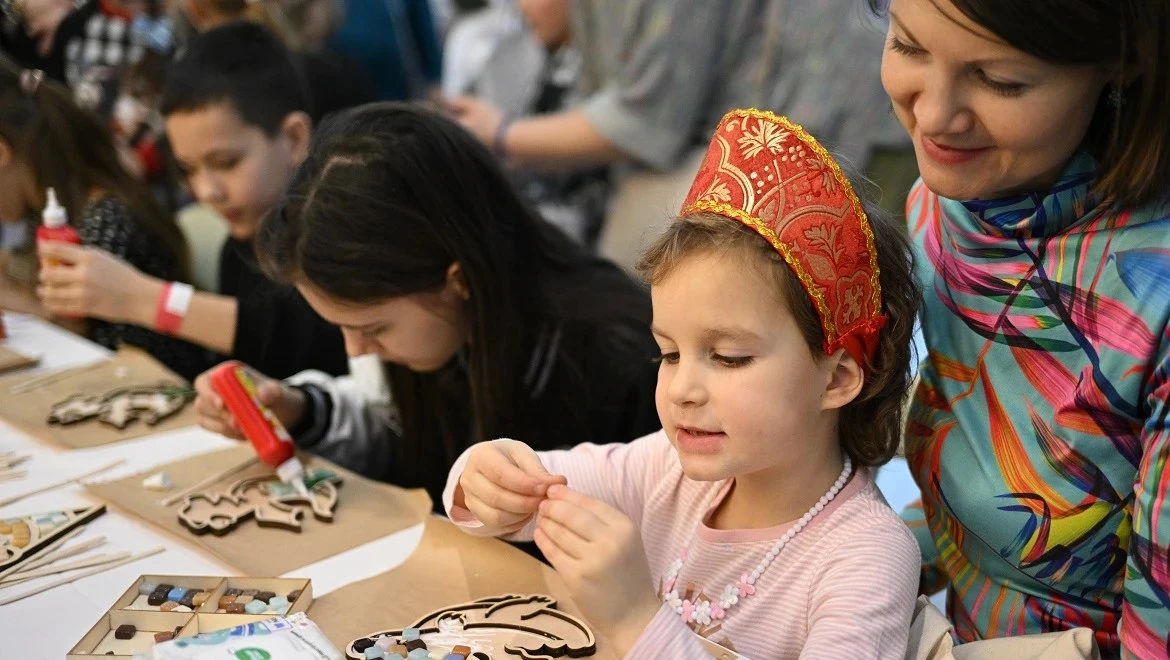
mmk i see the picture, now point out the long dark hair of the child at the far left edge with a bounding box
[0,59,190,280]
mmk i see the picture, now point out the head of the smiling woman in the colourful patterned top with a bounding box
[870,0,1170,205]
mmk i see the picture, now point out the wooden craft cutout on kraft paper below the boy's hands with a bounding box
[48,383,193,431]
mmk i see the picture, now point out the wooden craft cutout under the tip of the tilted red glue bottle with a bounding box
[179,470,342,536]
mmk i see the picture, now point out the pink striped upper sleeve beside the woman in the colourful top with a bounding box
[800,511,921,660]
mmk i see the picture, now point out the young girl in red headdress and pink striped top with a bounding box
[445,110,918,660]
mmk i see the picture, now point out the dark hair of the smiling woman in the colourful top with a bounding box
[868,0,1170,207]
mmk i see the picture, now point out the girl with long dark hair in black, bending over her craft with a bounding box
[195,103,658,506]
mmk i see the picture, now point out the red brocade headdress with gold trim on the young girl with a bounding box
[681,110,887,365]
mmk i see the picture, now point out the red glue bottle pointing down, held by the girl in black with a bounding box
[211,360,309,497]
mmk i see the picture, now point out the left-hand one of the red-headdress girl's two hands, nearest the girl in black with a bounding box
[454,440,566,534]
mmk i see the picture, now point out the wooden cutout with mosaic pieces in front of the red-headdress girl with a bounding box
[345,594,597,660]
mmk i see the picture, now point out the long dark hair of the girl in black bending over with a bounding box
[256,103,649,470]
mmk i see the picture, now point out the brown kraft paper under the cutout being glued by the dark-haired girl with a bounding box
[85,445,431,576]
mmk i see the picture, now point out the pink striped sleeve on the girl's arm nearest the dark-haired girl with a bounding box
[442,431,677,541]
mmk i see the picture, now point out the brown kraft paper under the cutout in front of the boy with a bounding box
[0,348,197,449]
